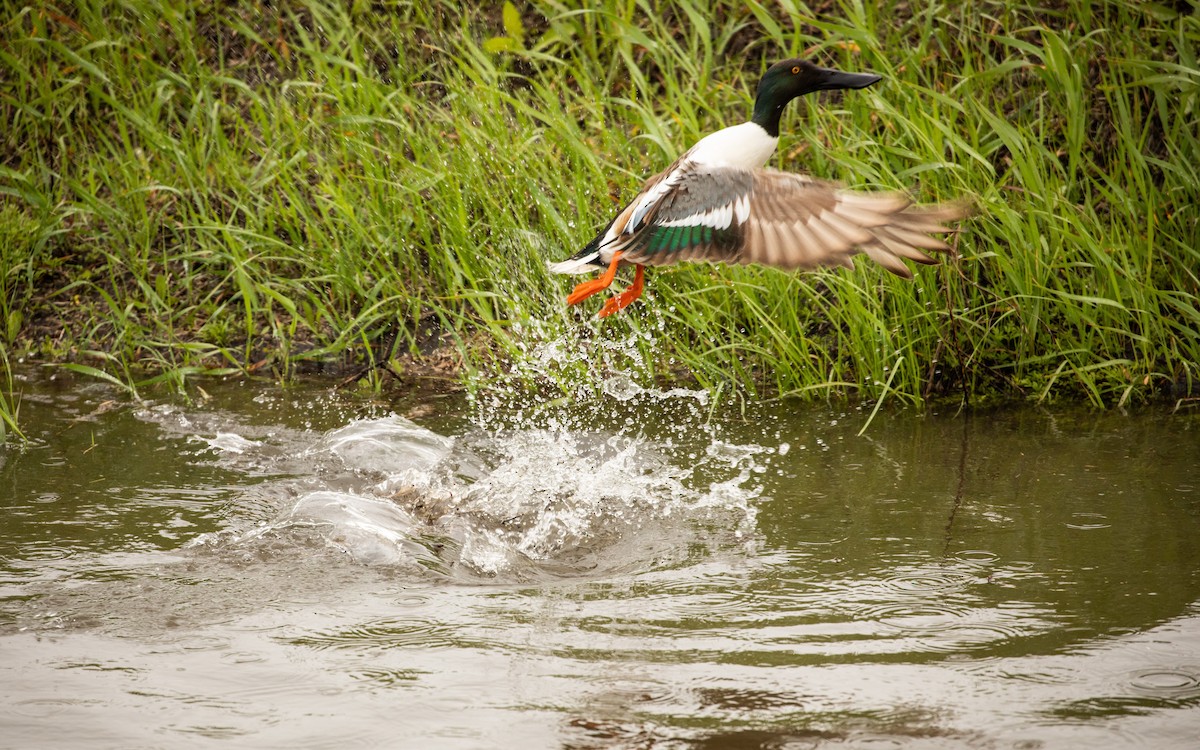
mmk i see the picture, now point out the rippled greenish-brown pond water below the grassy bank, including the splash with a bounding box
[0,360,1200,749]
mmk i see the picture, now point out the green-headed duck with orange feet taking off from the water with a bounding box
[550,58,966,318]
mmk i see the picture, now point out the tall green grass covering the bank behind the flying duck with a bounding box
[0,0,1200,436]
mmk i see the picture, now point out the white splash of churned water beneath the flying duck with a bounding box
[184,319,775,578]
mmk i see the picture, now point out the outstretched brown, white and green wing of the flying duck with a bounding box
[610,166,966,278]
